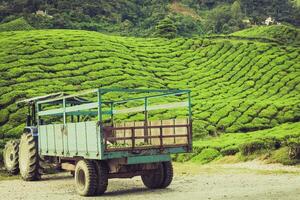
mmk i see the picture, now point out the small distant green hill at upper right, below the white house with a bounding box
[231,25,300,45]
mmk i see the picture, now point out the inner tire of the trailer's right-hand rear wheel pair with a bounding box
[141,163,164,189]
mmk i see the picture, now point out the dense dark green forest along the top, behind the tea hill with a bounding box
[0,0,300,37]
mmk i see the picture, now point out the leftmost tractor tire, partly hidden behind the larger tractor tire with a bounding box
[3,140,20,175]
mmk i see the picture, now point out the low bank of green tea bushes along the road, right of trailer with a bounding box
[190,122,300,164]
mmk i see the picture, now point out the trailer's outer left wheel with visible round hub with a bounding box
[75,160,97,196]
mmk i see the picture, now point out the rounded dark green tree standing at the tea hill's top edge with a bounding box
[155,16,177,39]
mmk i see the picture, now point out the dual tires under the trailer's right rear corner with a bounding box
[142,161,173,189]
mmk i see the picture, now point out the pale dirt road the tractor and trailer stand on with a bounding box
[0,163,300,200]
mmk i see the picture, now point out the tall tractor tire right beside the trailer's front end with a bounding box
[19,133,41,181]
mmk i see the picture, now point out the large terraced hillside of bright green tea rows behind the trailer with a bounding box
[0,30,300,143]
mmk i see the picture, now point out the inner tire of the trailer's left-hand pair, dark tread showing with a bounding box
[94,161,109,195]
